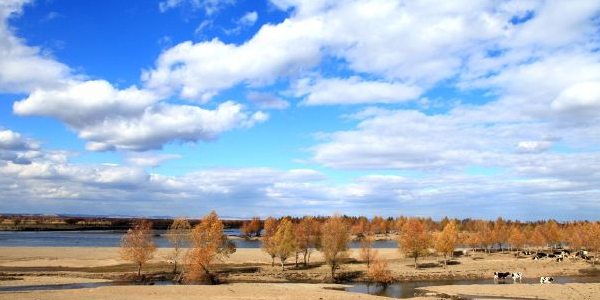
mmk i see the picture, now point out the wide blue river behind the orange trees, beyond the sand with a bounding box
[0,229,398,248]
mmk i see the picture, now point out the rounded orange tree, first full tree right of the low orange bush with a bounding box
[398,218,431,268]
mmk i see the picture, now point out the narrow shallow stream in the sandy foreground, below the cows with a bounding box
[346,276,600,298]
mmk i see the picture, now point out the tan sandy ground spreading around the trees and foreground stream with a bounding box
[0,247,600,300]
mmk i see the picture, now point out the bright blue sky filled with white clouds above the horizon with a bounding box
[0,0,600,220]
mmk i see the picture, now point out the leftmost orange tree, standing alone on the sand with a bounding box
[119,220,156,277]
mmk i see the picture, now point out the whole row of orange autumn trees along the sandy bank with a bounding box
[122,212,600,282]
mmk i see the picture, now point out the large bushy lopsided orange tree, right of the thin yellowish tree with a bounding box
[186,211,235,283]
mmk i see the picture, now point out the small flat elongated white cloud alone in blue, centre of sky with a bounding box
[294,77,422,105]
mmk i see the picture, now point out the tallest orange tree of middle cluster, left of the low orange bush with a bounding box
[320,215,350,281]
